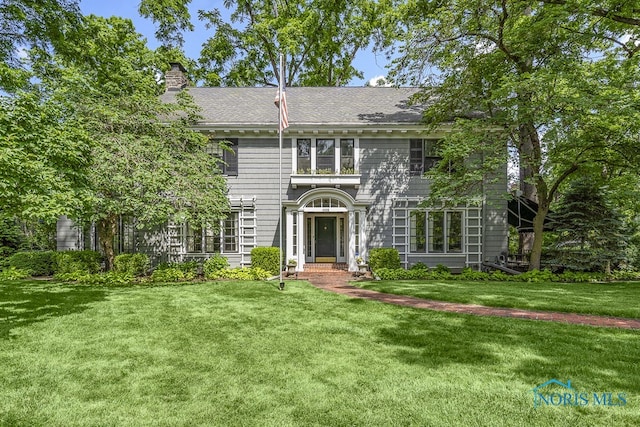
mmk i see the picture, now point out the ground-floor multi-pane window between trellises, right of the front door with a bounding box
[409,210,463,253]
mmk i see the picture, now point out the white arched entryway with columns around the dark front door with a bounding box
[285,188,367,271]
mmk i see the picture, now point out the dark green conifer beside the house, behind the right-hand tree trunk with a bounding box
[550,177,628,273]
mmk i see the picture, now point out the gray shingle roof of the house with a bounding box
[162,87,422,127]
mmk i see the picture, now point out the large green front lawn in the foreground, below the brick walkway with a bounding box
[0,281,640,426]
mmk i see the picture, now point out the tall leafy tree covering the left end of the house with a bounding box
[39,16,228,269]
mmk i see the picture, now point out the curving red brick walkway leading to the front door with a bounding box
[299,271,640,329]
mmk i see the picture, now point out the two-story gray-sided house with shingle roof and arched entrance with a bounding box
[58,67,508,271]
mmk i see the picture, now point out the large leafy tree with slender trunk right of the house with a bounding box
[394,0,640,269]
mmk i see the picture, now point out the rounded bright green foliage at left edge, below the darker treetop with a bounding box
[0,93,90,222]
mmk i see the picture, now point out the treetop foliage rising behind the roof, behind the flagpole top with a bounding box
[196,0,390,86]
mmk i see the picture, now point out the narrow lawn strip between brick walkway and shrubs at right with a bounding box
[356,280,640,318]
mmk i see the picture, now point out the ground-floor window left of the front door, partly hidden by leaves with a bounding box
[185,212,238,253]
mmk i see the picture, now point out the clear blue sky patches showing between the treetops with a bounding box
[80,0,387,86]
